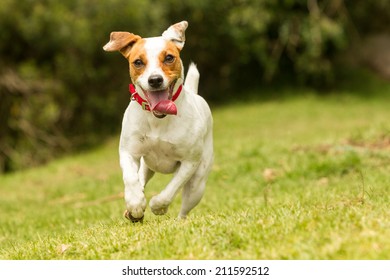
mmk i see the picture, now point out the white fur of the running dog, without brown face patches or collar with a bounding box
[104,21,213,221]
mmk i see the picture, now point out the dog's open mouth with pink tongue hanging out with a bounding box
[142,82,177,118]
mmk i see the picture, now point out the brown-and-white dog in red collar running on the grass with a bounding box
[103,21,214,222]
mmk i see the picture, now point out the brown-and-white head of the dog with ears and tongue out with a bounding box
[103,21,188,115]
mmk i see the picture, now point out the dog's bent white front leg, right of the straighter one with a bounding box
[149,161,199,215]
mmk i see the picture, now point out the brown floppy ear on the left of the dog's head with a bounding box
[103,32,141,58]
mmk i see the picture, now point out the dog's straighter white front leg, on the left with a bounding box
[119,150,146,222]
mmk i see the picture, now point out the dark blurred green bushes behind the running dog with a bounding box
[0,0,390,172]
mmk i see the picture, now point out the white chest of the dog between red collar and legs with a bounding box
[121,104,205,173]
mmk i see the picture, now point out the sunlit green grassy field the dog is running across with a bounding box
[0,86,390,259]
